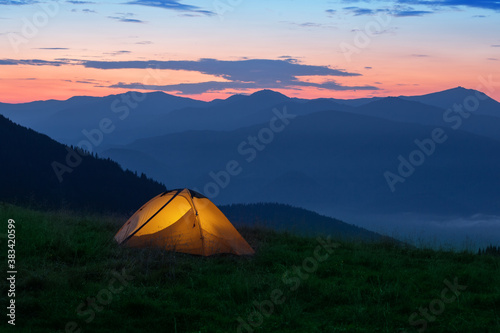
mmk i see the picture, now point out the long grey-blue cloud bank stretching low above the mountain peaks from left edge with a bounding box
[0,56,379,94]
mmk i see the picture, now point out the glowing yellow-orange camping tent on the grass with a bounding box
[115,189,254,256]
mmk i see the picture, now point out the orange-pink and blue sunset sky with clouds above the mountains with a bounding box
[0,0,500,103]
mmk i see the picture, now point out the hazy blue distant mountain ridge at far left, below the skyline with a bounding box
[0,92,207,146]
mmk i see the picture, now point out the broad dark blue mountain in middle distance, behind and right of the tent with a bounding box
[99,107,500,214]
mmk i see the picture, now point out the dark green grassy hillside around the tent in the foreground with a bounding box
[0,204,500,332]
